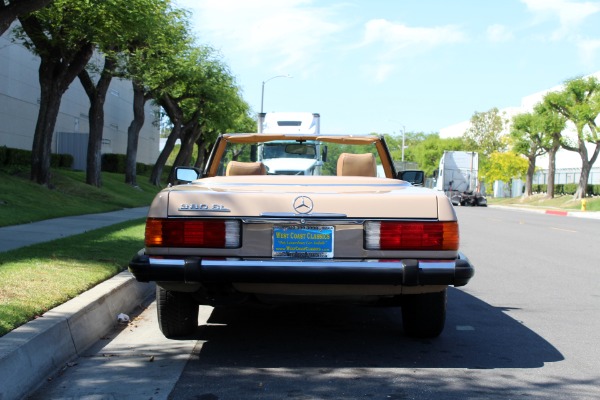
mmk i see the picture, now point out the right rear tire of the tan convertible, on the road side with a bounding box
[402,289,447,338]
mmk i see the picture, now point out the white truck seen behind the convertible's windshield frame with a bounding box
[257,112,327,175]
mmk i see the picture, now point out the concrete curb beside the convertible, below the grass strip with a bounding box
[0,272,155,399]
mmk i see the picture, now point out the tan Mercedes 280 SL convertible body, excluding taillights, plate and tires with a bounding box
[130,134,472,334]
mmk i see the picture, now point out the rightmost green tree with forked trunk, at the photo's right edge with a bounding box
[544,77,600,199]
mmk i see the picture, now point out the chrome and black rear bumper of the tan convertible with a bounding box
[129,253,475,286]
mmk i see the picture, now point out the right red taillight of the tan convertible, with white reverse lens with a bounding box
[365,221,459,250]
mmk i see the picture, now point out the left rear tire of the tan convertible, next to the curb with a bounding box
[156,286,198,338]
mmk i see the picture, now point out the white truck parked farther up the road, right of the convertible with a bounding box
[436,151,487,206]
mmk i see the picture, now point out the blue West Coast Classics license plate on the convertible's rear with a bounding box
[273,226,333,258]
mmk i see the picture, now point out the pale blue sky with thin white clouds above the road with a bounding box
[175,0,600,135]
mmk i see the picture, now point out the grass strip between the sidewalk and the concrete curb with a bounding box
[0,219,145,336]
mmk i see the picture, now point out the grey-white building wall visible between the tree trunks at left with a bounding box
[0,23,159,169]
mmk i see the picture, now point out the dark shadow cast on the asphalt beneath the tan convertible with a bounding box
[184,289,563,369]
